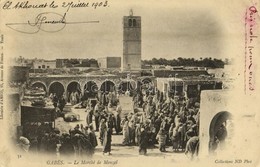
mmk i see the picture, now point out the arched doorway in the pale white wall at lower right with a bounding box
[209,111,232,154]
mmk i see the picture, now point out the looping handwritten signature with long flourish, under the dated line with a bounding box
[6,12,99,34]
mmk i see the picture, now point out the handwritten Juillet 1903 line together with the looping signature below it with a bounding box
[1,0,109,34]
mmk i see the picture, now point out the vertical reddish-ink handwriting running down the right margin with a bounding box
[244,6,258,93]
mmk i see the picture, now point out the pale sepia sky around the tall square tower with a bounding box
[2,0,244,60]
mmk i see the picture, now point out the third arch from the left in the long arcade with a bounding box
[67,81,81,105]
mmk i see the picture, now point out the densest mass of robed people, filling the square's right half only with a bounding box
[123,90,199,154]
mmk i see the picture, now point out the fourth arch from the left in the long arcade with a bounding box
[82,81,98,100]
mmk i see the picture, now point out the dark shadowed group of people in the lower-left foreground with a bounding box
[19,123,97,157]
